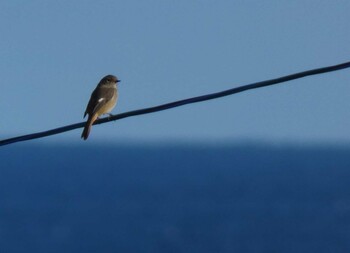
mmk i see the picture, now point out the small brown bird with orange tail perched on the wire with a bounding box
[81,75,120,140]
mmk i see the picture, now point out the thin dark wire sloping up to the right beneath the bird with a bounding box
[0,62,350,146]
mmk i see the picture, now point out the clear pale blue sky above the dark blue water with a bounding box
[0,0,350,144]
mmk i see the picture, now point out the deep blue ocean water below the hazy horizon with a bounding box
[0,143,350,253]
